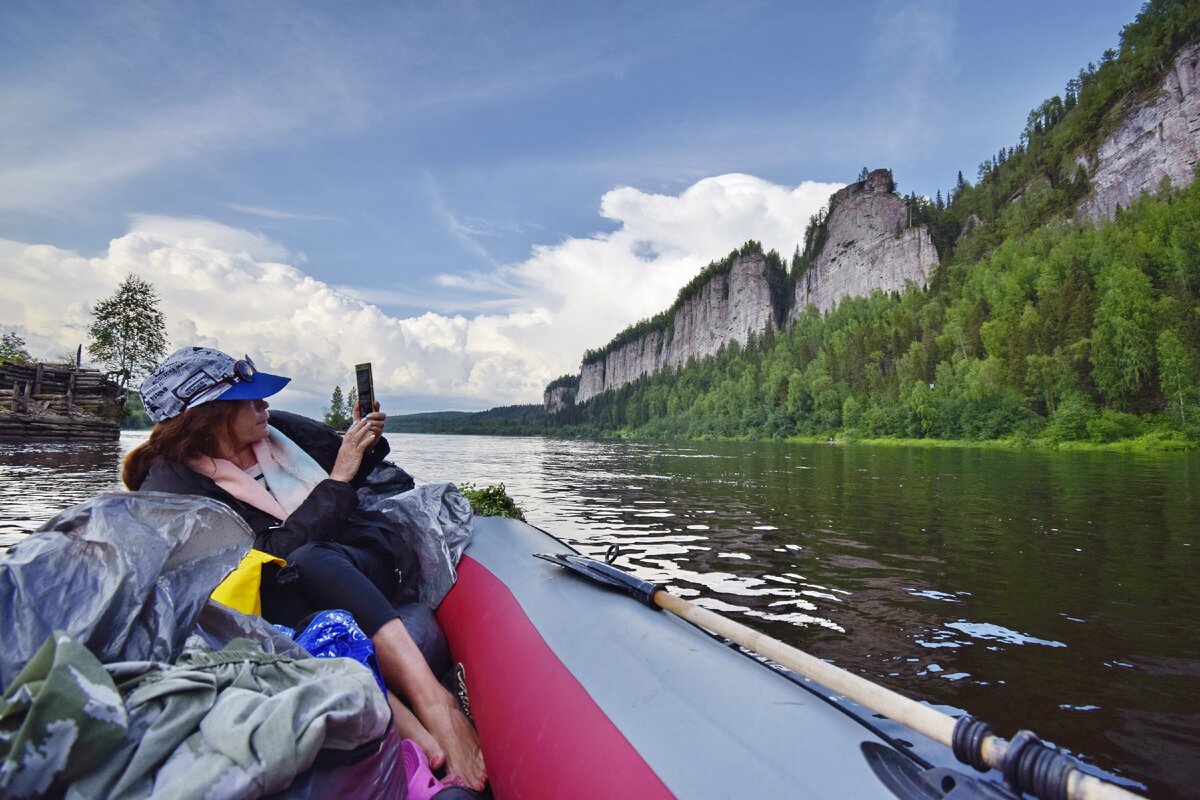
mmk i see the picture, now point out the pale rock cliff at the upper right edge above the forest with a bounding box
[1079,43,1200,221]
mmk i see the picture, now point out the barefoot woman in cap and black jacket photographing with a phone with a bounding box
[121,347,487,789]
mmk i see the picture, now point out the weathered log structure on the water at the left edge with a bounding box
[0,361,125,441]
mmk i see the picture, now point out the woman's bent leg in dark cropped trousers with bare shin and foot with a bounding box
[288,542,487,789]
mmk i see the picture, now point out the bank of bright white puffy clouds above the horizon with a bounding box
[0,174,839,413]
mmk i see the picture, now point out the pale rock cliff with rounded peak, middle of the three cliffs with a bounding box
[790,169,938,319]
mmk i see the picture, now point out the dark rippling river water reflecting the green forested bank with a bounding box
[0,433,1200,798]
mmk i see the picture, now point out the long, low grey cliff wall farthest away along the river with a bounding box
[576,254,784,408]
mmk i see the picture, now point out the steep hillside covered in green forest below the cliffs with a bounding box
[550,0,1200,446]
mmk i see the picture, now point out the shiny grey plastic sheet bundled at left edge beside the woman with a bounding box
[0,492,252,686]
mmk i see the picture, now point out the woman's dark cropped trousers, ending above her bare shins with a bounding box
[262,541,400,636]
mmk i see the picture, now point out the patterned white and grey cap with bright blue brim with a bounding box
[138,347,292,422]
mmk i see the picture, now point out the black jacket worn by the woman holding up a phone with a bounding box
[139,410,412,561]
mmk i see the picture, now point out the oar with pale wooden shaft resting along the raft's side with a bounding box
[534,549,1140,800]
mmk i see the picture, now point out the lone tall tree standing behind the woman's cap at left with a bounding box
[88,272,167,389]
